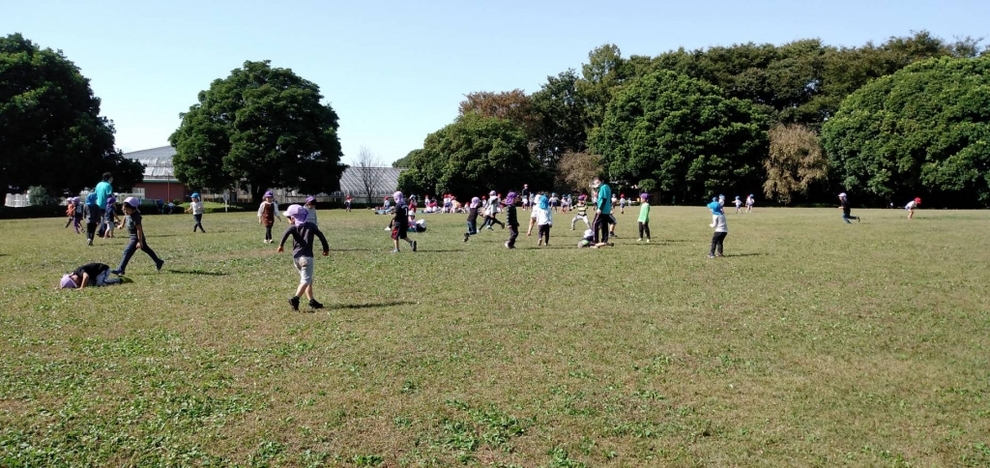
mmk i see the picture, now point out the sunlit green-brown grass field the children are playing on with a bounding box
[0,207,990,467]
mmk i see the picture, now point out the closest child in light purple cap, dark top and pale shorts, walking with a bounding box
[275,205,330,311]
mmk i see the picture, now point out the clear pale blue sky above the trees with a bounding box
[0,0,990,163]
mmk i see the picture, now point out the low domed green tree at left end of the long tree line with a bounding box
[399,113,548,198]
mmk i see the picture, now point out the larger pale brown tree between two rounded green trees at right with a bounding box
[763,124,828,205]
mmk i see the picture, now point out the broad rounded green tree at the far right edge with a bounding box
[822,57,990,206]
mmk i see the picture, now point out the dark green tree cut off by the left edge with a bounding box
[0,34,144,194]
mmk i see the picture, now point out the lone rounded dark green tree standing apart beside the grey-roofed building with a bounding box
[169,60,345,201]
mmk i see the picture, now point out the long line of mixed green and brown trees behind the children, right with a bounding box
[395,31,990,207]
